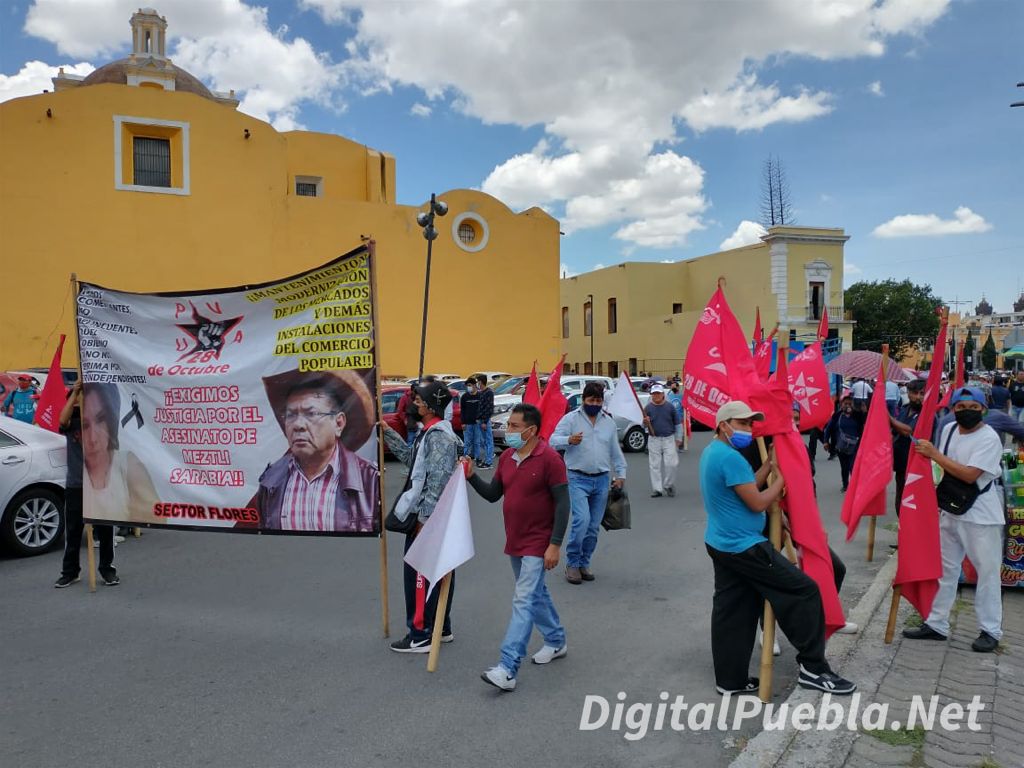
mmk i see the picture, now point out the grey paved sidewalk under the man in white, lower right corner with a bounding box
[845,588,1024,768]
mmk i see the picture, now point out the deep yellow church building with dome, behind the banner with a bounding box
[0,10,560,376]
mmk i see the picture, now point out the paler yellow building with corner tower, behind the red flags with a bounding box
[560,226,853,376]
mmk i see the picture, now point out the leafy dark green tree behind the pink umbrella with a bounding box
[845,280,942,359]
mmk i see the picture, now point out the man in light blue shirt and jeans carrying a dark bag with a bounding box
[548,382,626,584]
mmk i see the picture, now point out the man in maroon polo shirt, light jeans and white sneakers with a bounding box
[463,402,569,691]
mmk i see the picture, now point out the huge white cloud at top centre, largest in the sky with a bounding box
[309,0,947,247]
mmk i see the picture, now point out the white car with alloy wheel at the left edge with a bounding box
[0,417,68,555]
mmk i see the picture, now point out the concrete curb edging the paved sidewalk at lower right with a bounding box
[729,555,907,768]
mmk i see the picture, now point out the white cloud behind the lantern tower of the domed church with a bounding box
[25,0,343,130]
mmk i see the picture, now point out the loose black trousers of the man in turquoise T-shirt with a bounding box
[706,542,830,689]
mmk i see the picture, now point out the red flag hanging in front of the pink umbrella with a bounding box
[840,358,893,541]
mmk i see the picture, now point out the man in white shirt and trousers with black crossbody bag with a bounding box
[903,387,1006,653]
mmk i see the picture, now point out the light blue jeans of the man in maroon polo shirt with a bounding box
[502,555,565,677]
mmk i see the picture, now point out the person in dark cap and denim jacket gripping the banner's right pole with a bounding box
[384,381,462,653]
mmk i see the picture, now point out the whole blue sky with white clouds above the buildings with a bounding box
[6,0,1024,311]
